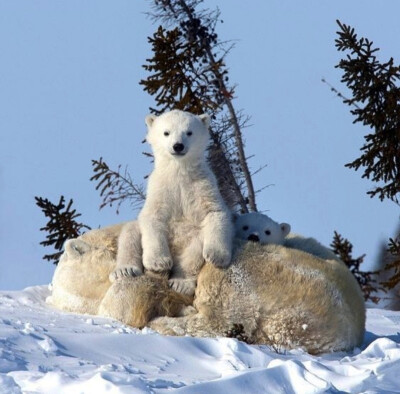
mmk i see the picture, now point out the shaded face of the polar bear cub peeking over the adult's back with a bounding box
[235,212,290,245]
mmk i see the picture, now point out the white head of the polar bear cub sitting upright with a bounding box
[146,110,210,161]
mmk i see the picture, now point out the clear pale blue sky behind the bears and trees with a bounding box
[0,0,400,289]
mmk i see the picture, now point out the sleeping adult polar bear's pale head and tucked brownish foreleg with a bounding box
[46,222,193,328]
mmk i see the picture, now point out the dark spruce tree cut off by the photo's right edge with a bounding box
[336,21,400,290]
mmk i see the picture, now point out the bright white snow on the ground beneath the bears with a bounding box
[0,286,400,394]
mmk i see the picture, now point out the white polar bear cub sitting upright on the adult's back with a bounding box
[114,110,234,295]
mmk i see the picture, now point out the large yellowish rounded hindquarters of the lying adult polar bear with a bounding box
[150,237,365,354]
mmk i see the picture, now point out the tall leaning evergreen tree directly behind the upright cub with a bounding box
[140,0,257,213]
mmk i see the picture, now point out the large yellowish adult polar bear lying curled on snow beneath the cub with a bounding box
[48,224,365,353]
